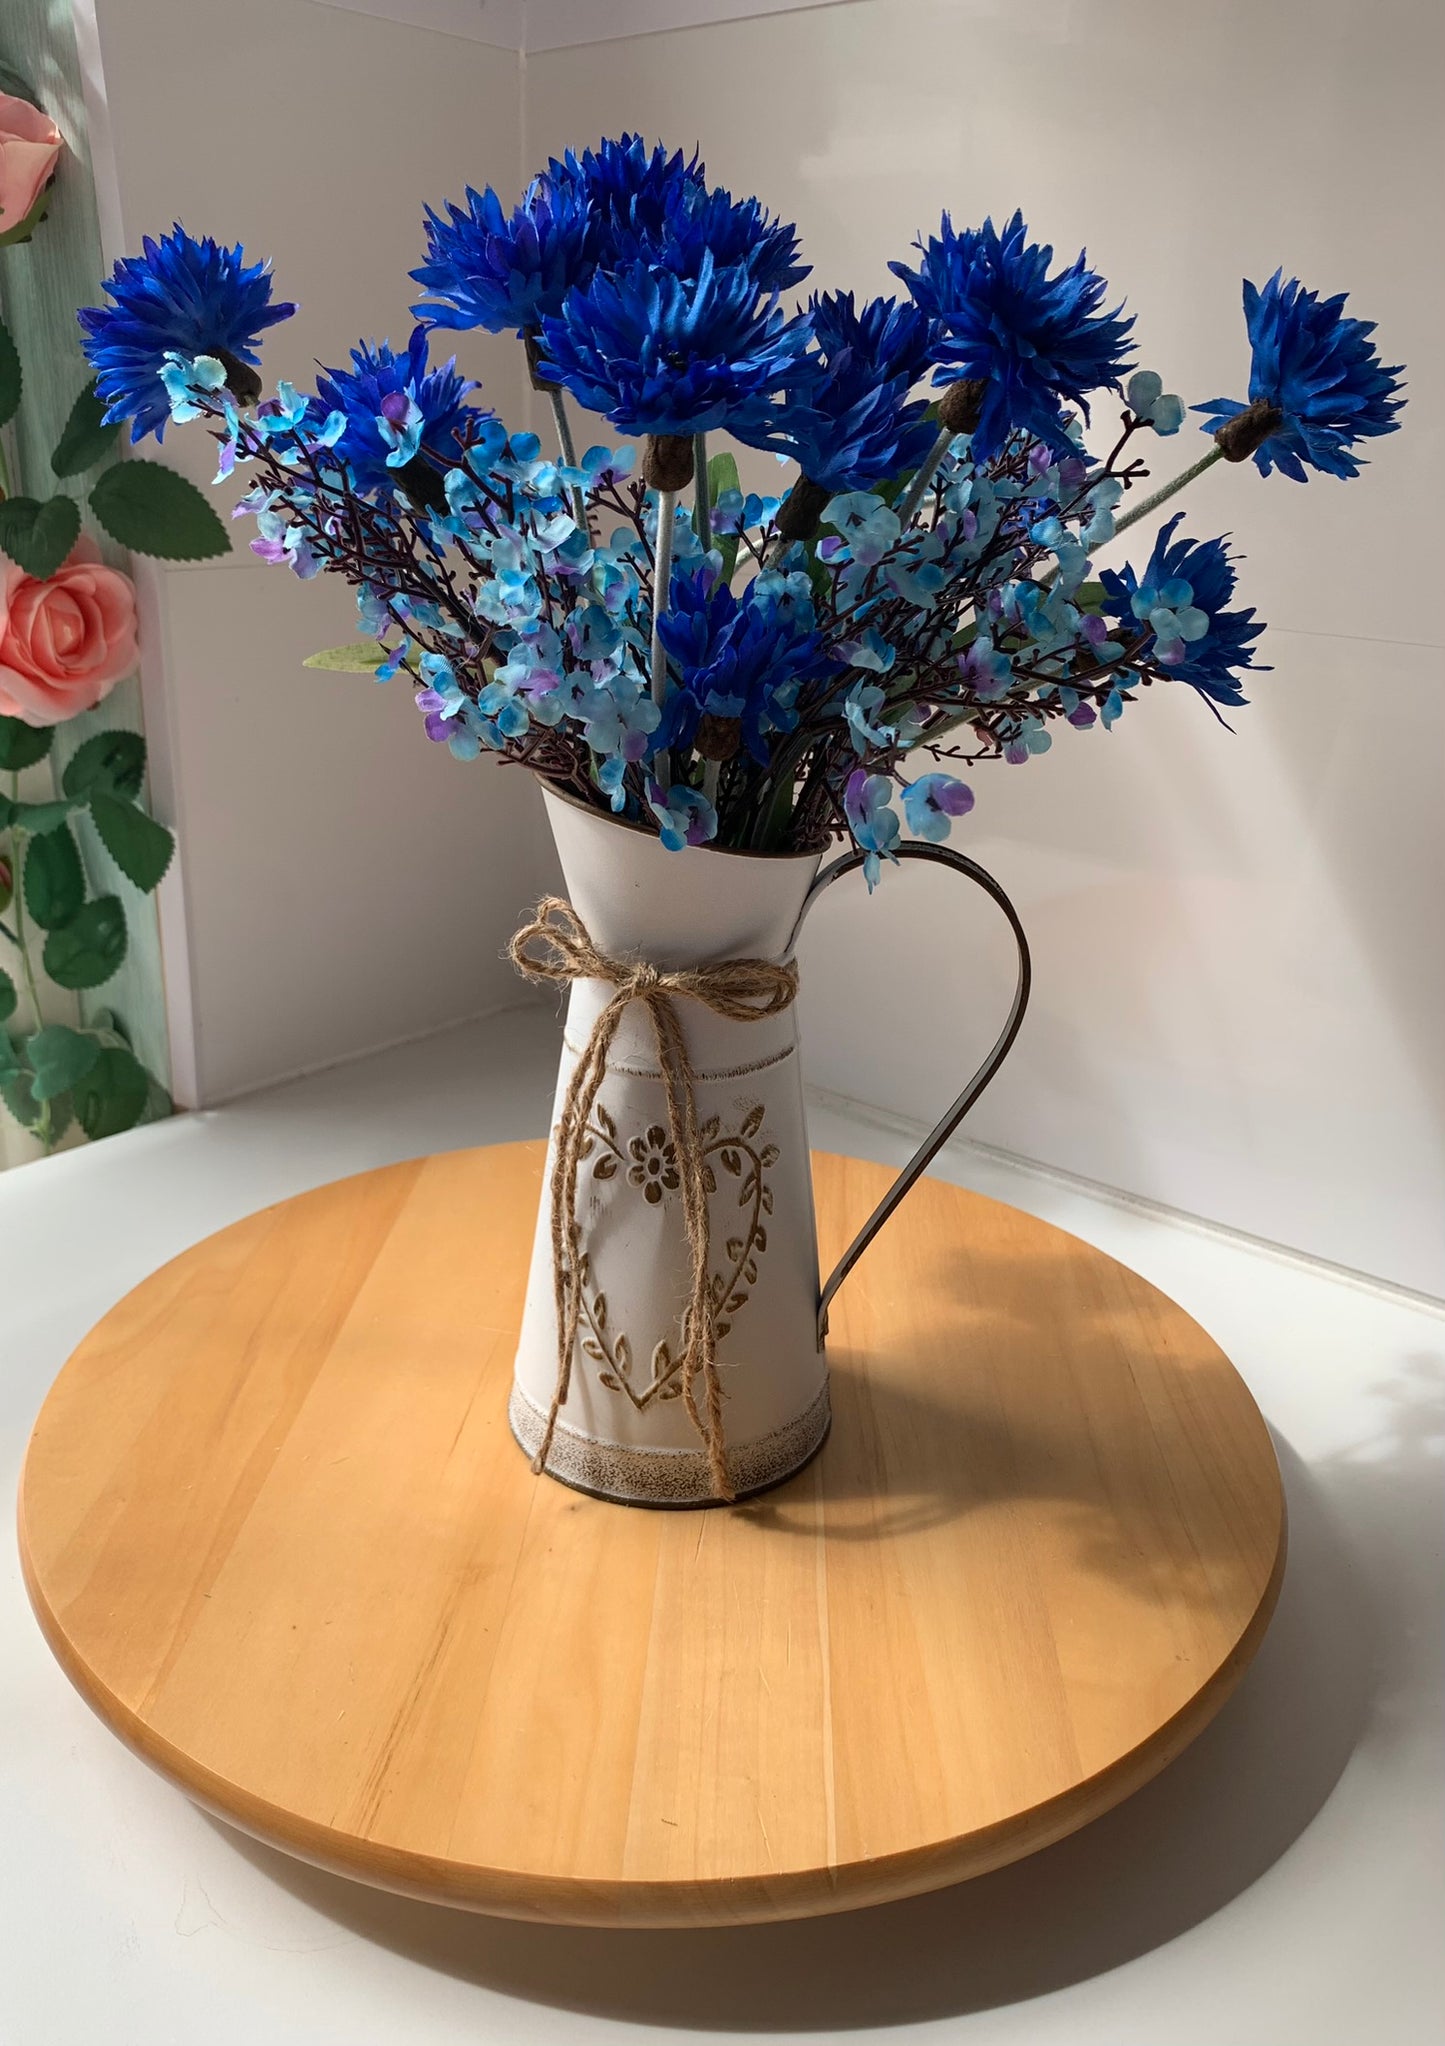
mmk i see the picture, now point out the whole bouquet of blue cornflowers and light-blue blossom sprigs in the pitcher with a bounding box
[80,135,1402,884]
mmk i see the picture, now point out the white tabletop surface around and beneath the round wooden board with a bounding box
[0,1011,1445,2046]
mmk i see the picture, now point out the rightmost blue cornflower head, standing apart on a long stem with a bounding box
[1193,270,1404,483]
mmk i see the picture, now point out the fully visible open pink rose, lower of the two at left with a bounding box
[0,534,135,724]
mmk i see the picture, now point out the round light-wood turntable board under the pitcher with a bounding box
[20,1144,1283,1925]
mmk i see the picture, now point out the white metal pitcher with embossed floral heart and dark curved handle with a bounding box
[510,786,1030,1506]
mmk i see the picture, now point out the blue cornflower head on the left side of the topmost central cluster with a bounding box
[411,164,592,333]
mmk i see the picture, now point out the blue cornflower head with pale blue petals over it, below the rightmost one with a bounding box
[1099,512,1267,706]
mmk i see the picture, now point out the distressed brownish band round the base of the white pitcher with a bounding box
[508,1381,833,1506]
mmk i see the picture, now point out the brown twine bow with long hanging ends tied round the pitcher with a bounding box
[508,896,798,1500]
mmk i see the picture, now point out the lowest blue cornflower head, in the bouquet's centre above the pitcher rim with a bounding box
[657,559,837,765]
